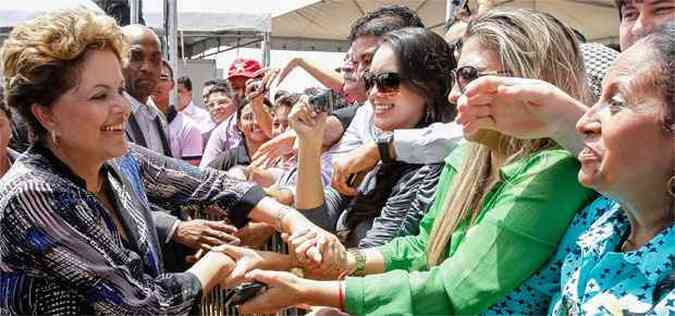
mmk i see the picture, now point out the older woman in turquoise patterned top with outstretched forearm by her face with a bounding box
[461,23,675,315]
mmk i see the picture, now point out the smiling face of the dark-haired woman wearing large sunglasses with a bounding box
[368,44,426,131]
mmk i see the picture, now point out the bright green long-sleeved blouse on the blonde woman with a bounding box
[345,147,594,315]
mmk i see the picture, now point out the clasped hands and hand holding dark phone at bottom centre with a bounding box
[211,228,363,312]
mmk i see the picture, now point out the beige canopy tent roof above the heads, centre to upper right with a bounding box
[272,0,618,51]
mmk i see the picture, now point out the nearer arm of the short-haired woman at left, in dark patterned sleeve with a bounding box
[0,181,233,315]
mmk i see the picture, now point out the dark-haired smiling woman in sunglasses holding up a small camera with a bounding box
[290,28,454,248]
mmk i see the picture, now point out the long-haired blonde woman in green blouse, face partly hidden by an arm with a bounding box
[223,10,592,315]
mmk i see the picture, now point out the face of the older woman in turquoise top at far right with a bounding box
[577,41,675,198]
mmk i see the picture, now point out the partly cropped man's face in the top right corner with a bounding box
[619,0,675,51]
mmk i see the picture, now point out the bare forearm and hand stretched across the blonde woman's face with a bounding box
[457,76,588,156]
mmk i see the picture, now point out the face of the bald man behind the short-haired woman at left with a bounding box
[124,29,162,102]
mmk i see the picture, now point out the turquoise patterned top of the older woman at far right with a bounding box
[486,197,675,315]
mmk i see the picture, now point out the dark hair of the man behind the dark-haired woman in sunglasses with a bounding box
[348,5,424,42]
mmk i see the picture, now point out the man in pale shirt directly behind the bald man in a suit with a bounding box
[151,60,203,166]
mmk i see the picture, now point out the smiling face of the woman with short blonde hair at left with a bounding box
[38,50,130,162]
